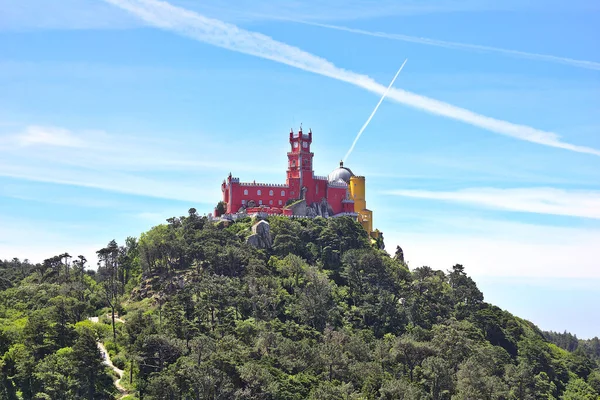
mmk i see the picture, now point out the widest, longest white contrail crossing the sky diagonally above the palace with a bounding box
[105,0,600,156]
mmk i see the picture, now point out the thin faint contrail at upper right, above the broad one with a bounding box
[291,20,600,70]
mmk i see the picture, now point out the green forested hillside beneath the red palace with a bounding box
[0,209,600,400]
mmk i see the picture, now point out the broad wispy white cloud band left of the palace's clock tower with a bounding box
[0,126,279,203]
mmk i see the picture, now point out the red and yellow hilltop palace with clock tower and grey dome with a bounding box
[215,128,378,237]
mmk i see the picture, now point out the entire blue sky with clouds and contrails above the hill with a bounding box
[0,0,600,338]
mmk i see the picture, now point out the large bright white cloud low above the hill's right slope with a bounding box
[384,217,600,279]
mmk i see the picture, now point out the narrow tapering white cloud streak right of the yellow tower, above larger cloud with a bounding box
[386,188,600,219]
